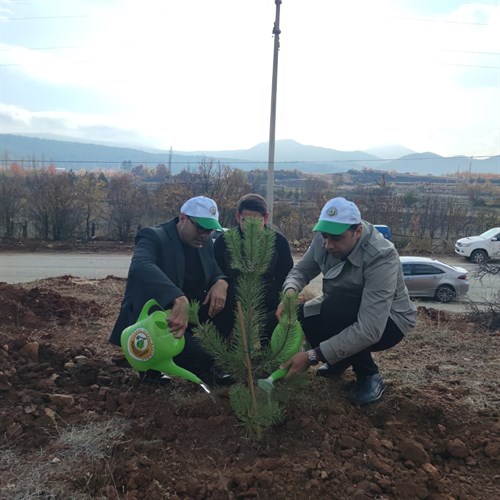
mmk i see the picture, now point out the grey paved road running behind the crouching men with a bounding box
[0,252,500,311]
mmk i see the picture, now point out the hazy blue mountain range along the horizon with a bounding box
[0,134,500,175]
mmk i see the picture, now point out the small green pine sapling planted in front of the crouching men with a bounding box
[196,218,302,438]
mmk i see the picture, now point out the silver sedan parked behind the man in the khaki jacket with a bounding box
[400,257,469,302]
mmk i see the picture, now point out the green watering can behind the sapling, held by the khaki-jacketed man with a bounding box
[257,317,304,392]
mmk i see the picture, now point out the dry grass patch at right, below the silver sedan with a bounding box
[377,311,500,414]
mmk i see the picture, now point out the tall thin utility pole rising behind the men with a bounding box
[267,0,281,224]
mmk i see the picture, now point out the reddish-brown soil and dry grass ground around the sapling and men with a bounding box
[0,247,500,500]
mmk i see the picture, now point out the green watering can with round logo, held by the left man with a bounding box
[120,299,210,393]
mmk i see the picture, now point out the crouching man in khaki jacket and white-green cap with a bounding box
[277,198,417,405]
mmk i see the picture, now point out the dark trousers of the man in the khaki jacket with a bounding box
[299,293,404,376]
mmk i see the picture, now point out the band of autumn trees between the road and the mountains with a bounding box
[0,159,498,251]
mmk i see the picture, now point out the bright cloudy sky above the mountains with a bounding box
[0,0,500,156]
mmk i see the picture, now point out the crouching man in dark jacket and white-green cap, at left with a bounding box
[110,196,228,383]
